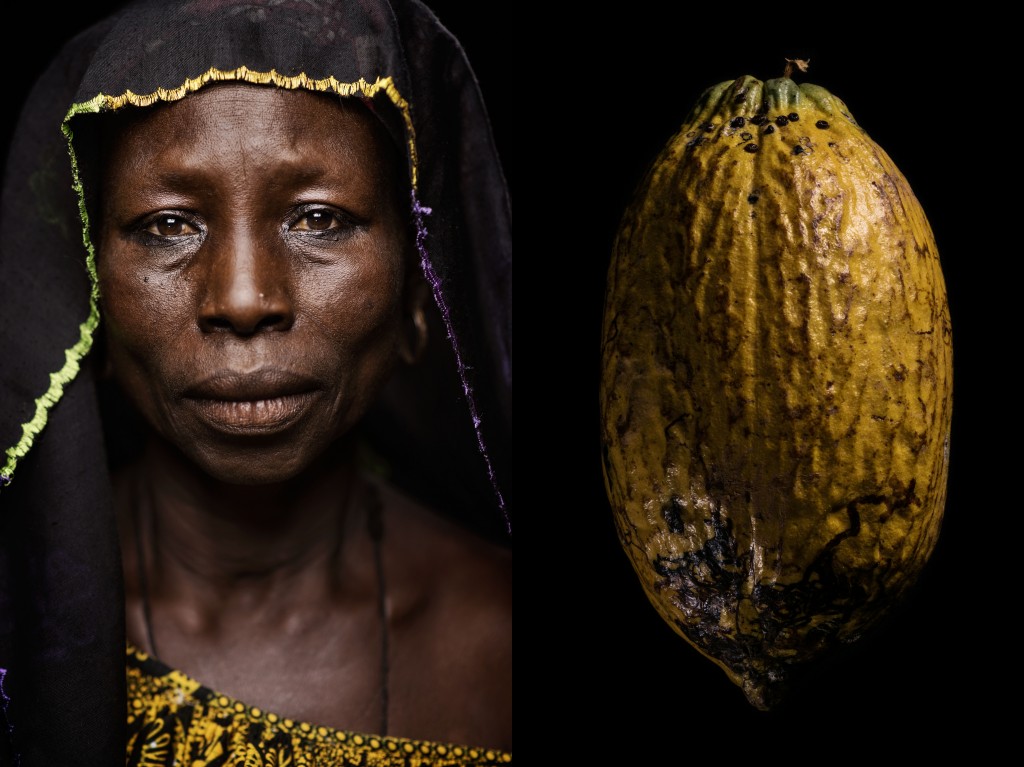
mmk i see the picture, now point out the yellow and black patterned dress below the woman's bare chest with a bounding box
[127,644,512,767]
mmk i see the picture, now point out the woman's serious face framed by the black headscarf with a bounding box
[97,84,408,483]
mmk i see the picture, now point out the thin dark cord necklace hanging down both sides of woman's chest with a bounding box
[133,479,390,735]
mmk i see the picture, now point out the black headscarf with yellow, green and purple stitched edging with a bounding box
[0,0,512,766]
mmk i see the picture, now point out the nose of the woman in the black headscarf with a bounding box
[199,230,295,336]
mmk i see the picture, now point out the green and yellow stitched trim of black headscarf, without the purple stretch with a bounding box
[0,67,419,486]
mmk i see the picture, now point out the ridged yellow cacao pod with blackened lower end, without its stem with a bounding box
[600,77,952,710]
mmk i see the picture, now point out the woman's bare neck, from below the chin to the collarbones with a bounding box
[130,440,362,607]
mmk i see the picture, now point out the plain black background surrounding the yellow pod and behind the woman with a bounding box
[4,2,1022,764]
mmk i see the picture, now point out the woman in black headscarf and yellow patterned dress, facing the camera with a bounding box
[0,0,511,765]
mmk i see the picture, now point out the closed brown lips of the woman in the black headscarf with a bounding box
[184,369,319,434]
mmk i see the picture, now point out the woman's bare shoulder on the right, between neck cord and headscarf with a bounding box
[372,479,512,752]
